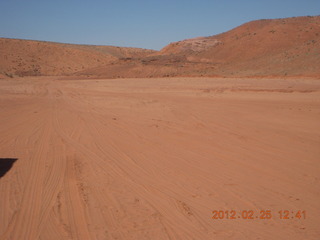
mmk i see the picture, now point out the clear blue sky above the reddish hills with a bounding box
[0,0,320,49]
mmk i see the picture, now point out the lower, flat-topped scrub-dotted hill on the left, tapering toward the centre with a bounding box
[0,38,155,76]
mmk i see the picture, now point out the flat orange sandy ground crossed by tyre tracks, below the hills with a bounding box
[0,78,320,240]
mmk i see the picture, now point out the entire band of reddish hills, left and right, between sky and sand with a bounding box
[0,16,320,78]
